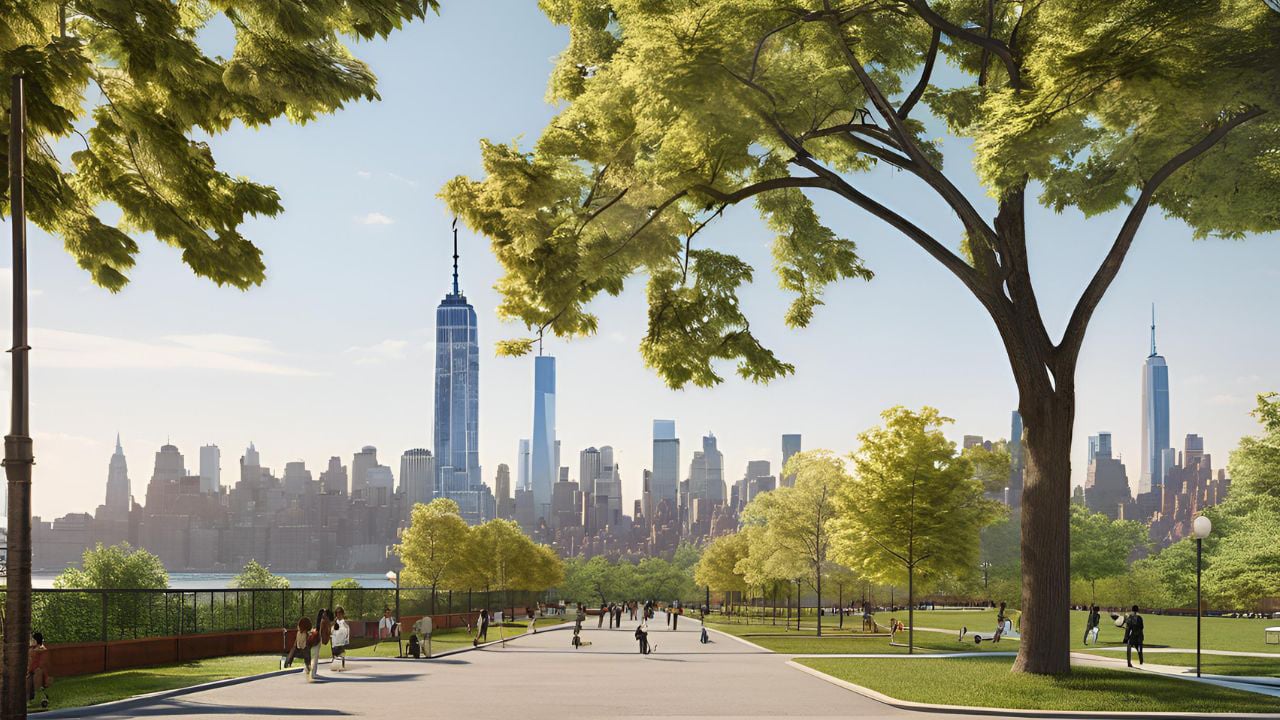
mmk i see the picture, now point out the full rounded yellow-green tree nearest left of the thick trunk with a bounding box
[836,407,1004,652]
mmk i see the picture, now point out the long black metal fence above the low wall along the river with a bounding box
[0,588,544,643]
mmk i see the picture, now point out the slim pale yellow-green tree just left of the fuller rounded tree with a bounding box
[744,450,850,637]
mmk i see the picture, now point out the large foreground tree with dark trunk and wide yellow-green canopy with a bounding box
[443,0,1280,673]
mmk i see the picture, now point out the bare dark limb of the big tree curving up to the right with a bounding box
[1057,108,1266,369]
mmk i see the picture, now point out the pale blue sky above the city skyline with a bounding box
[0,0,1280,519]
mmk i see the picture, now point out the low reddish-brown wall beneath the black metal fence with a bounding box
[49,607,529,678]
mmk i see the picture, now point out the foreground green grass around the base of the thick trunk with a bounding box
[797,657,1276,712]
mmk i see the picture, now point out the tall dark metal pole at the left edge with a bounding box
[0,76,36,720]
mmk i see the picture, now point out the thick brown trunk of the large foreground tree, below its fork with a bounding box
[1014,389,1075,675]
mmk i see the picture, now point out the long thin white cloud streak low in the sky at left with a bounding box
[31,328,323,377]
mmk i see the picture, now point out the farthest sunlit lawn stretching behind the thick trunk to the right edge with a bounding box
[896,610,1280,653]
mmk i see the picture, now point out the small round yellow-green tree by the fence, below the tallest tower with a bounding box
[396,497,470,615]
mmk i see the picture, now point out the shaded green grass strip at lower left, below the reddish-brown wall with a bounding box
[32,655,280,711]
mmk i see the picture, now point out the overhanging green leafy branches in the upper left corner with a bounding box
[0,0,438,292]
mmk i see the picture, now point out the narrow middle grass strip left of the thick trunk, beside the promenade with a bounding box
[707,623,1018,655]
